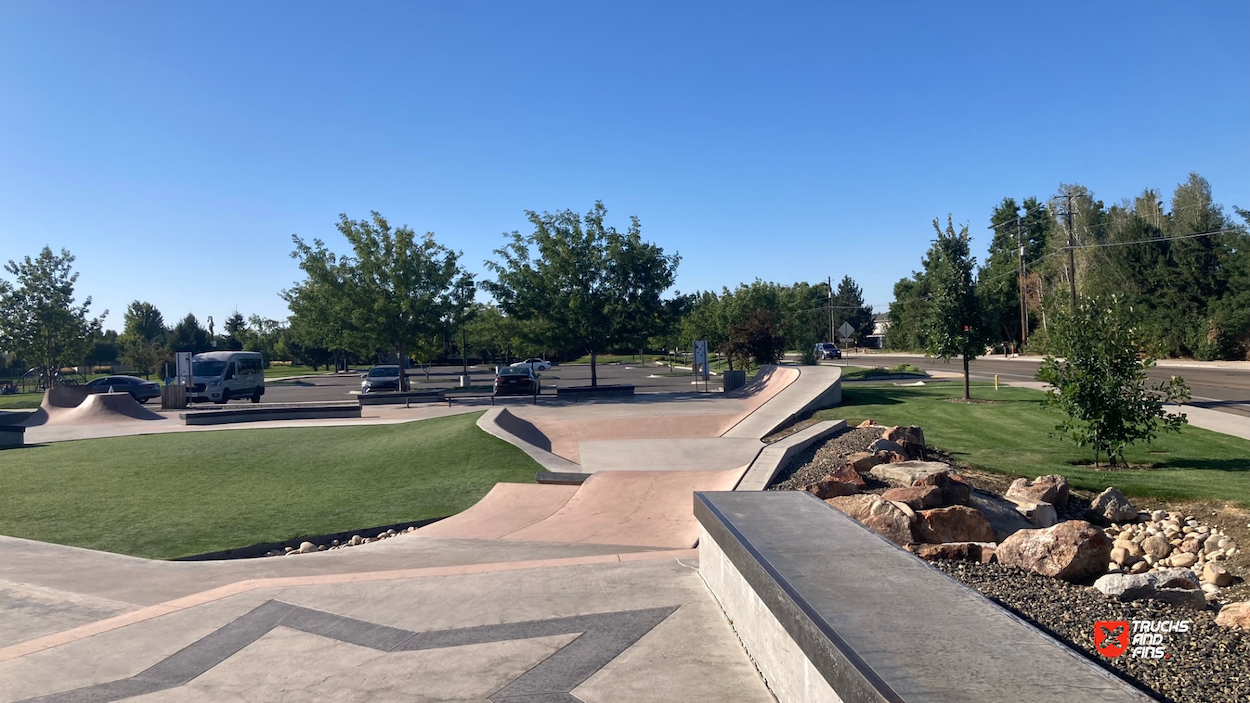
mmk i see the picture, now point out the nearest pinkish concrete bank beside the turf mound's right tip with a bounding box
[416,467,745,549]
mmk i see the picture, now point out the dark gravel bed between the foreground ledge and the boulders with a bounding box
[933,562,1250,703]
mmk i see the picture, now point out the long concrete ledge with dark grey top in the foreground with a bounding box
[694,490,1149,703]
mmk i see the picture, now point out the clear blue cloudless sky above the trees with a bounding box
[0,0,1250,329]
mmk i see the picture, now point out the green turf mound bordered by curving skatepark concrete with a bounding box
[0,413,540,559]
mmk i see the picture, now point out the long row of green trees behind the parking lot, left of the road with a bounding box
[0,203,873,384]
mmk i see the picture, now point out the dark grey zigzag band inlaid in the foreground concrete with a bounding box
[12,600,678,703]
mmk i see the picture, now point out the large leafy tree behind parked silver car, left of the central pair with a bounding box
[289,211,463,390]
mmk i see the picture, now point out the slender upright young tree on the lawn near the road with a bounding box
[925,215,986,400]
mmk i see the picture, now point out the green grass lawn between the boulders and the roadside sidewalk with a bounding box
[816,383,1250,505]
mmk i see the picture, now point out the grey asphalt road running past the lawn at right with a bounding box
[845,354,1250,418]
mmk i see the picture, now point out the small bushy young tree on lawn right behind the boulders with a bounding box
[1038,298,1189,467]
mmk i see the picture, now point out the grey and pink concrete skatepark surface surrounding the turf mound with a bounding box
[0,369,838,703]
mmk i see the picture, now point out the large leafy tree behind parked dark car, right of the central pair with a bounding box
[483,203,680,385]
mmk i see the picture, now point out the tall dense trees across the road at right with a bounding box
[886,174,1250,359]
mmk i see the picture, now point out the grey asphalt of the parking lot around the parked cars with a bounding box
[261,362,720,403]
